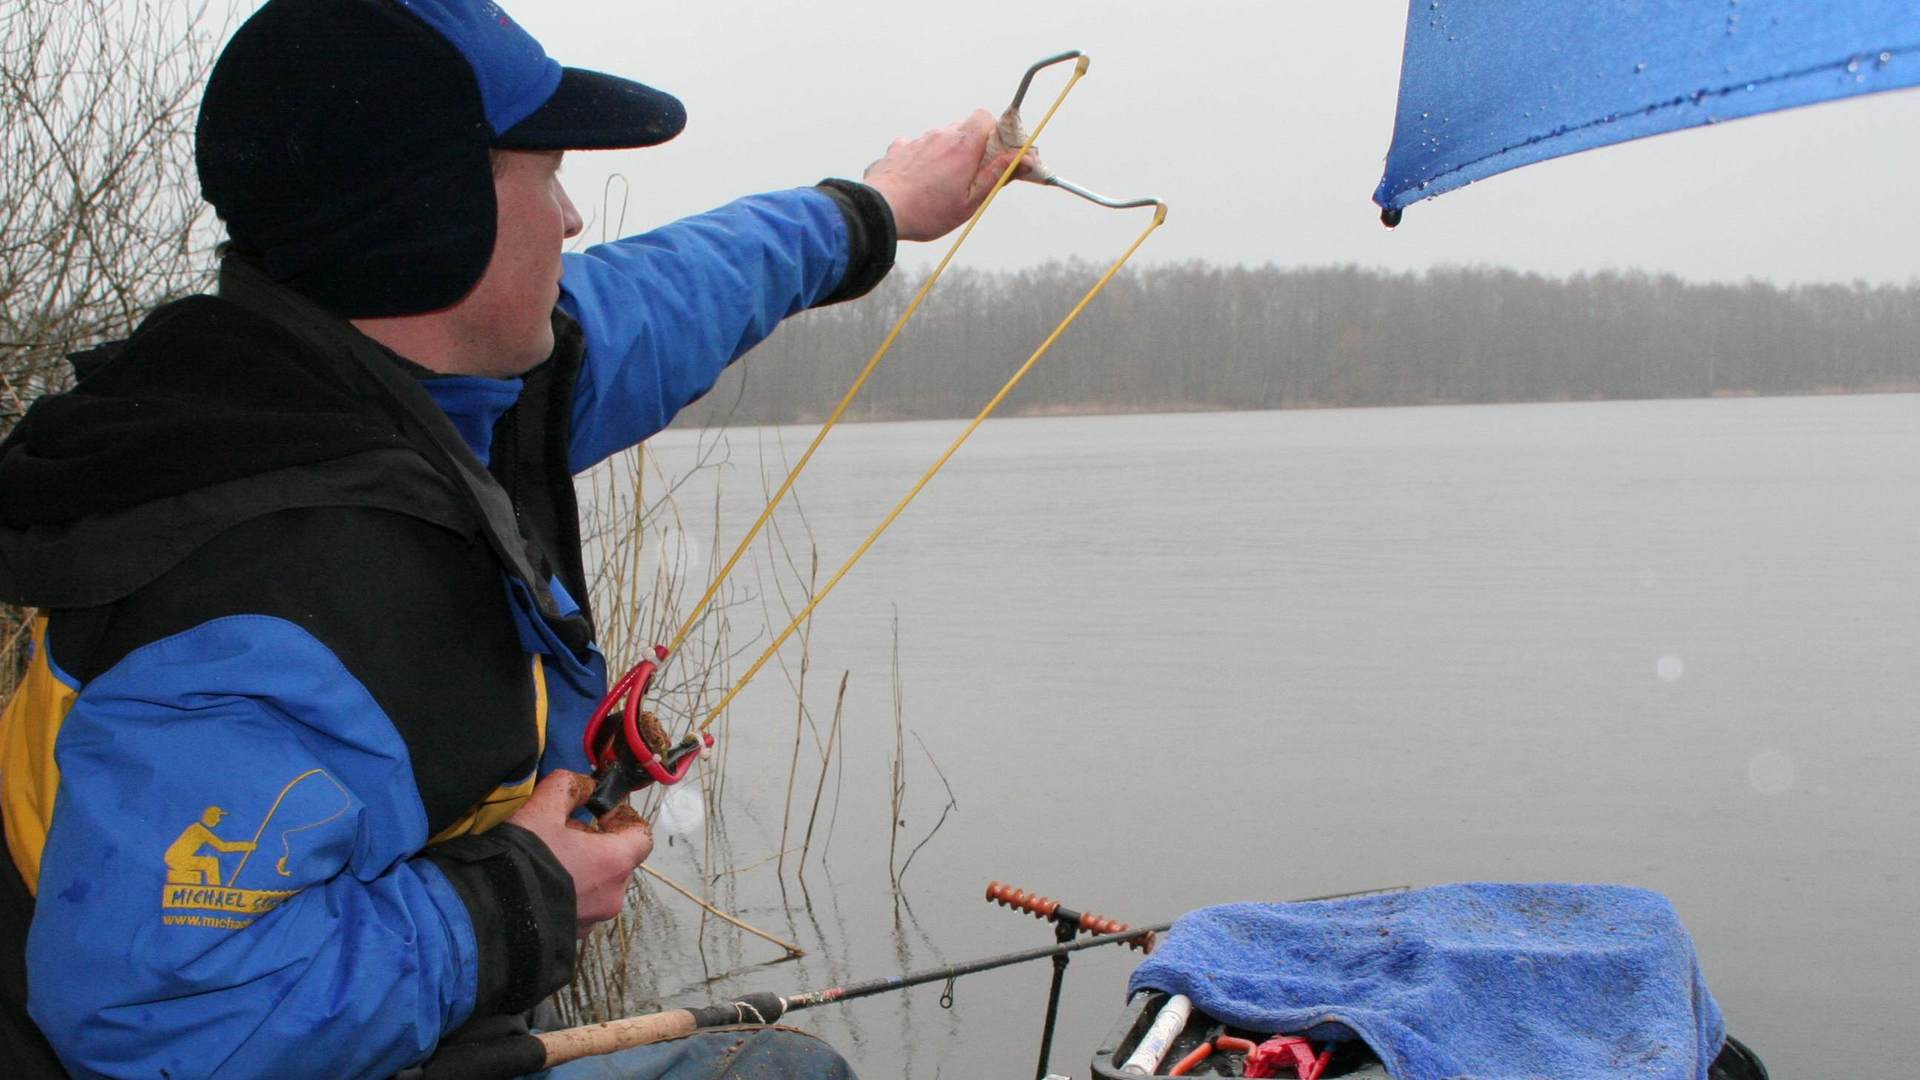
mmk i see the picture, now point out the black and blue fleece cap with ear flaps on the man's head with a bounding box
[194,0,685,317]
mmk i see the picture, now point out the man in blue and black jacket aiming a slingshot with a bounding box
[0,0,1008,1078]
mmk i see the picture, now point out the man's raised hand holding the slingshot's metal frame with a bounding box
[862,110,1027,240]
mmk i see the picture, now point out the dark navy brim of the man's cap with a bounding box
[493,67,687,150]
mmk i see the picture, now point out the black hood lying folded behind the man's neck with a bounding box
[0,258,593,651]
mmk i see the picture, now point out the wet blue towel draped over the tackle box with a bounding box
[1127,884,1726,1080]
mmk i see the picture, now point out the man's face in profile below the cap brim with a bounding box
[451,150,582,379]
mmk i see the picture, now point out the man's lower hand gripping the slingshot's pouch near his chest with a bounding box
[507,769,653,938]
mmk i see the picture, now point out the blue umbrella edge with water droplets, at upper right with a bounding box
[1373,0,1920,225]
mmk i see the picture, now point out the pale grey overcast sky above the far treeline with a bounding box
[228,0,1920,282]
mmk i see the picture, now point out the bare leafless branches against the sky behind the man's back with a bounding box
[0,0,215,432]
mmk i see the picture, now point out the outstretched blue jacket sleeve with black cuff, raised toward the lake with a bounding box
[561,181,895,473]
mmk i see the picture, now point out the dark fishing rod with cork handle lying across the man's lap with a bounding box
[405,922,1173,1080]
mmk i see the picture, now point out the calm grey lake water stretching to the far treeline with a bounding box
[603,396,1920,1080]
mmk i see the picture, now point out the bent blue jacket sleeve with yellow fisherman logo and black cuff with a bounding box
[27,615,572,1076]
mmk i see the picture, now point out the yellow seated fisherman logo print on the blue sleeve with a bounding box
[159,769,353,930]
